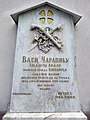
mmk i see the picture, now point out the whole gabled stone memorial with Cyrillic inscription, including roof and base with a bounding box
[3,2,86,120]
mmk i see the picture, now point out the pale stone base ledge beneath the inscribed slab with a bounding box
[3,112,87,120]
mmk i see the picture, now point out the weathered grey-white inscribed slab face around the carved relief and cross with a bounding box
[10,6,80,112]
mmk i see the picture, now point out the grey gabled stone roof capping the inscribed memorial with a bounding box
[11,2,81,25]
